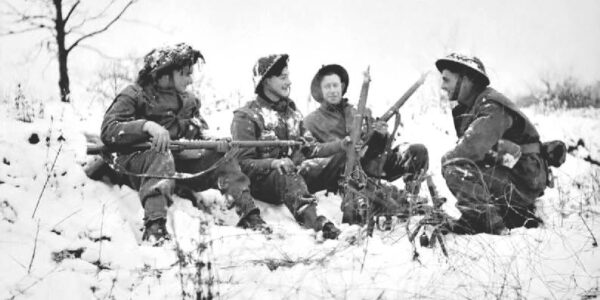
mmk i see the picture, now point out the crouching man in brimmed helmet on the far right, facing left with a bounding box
[435,53,548,234]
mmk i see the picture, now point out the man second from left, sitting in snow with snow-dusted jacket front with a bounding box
[231,54,347,239]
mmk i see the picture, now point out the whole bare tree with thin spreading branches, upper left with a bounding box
[0,0,138,102]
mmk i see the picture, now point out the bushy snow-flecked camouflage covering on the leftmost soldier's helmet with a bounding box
[140,43,204,76]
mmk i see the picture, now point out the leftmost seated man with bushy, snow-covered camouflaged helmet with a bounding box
[101,44,265,245]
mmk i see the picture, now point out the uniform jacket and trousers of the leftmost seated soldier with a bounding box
[101,85,257,221]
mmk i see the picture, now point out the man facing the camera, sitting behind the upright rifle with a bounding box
[304,64,429,224]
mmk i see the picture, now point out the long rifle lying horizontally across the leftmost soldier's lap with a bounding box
[87,140,304,155]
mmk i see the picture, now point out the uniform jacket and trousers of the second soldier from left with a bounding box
[231,95,343,231]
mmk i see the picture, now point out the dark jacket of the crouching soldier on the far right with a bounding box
[442,87,547,191]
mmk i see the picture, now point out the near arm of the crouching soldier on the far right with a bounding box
[442,100,513,164]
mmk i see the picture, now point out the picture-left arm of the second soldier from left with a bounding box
[231,112,274,176]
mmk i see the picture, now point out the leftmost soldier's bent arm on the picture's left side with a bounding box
[100,87,149,145]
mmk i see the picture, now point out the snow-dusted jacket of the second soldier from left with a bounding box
[231,96,343,177]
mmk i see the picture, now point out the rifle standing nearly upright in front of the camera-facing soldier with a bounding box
[342,67,371,224]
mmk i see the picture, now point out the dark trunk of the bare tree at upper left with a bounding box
[53,0,71,102]
